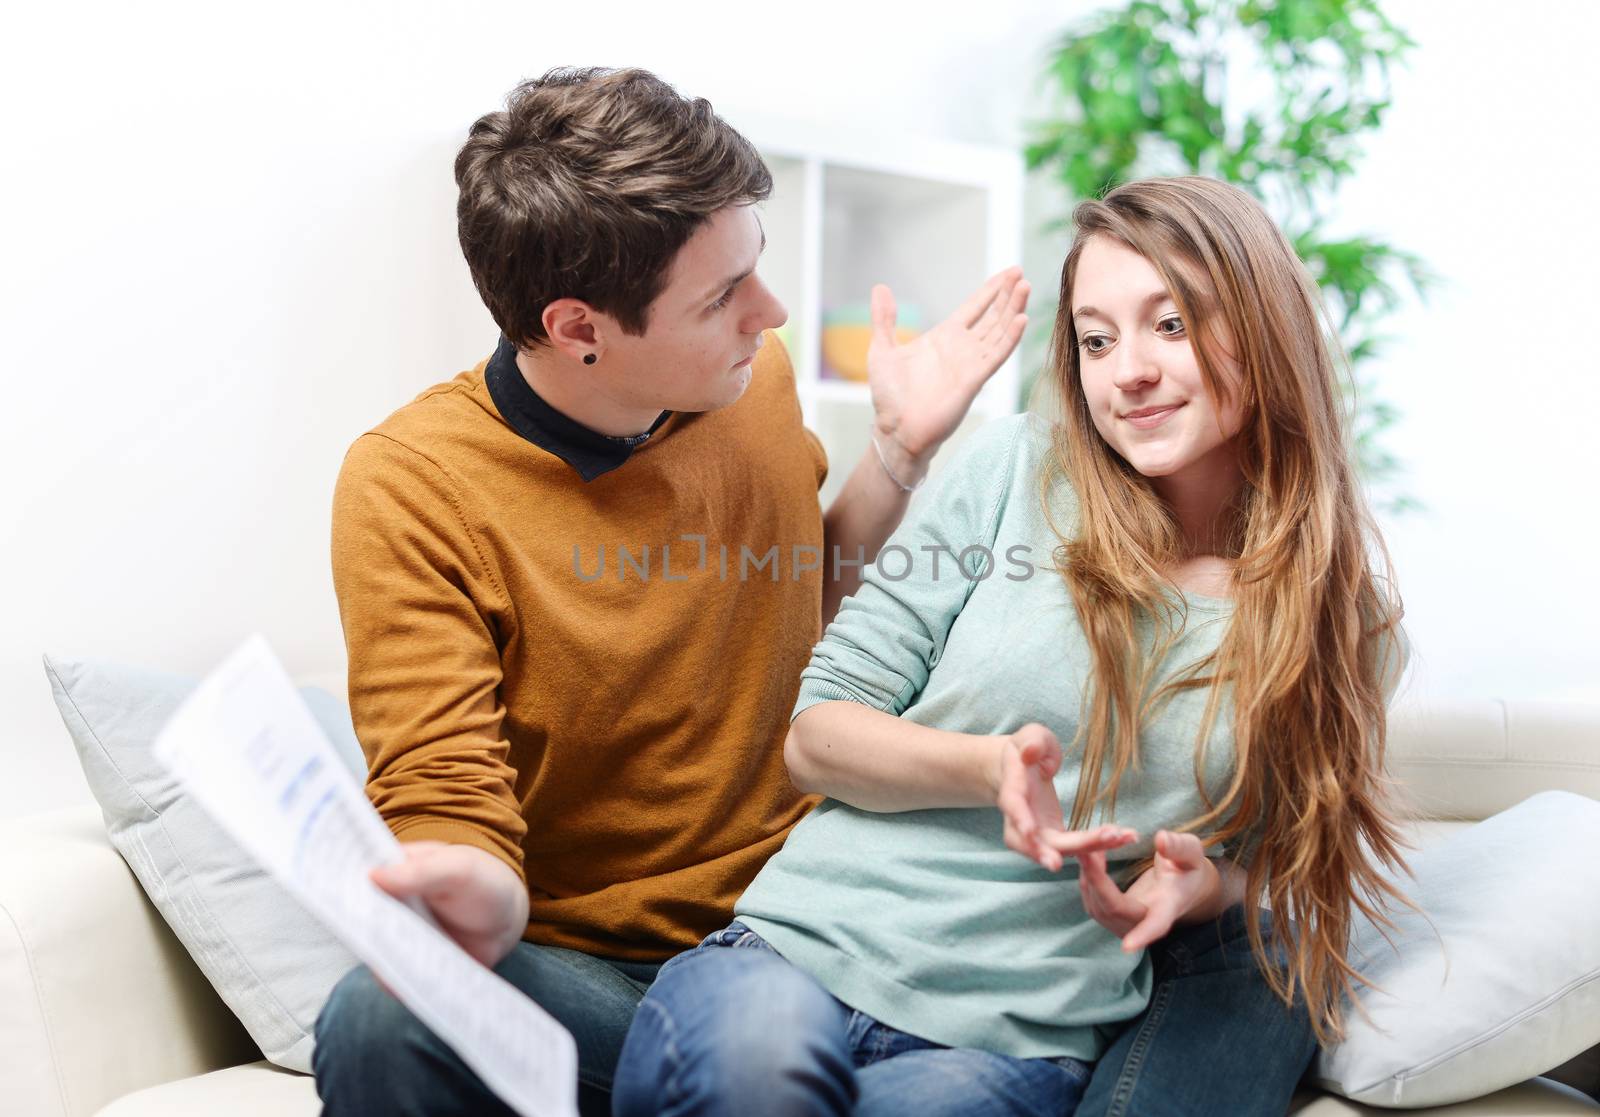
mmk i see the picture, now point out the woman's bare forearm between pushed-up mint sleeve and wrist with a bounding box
[784,701,1006,811]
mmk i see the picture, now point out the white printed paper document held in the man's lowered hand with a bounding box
[155,635,578,1117]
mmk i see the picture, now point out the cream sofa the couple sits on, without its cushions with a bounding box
[0,701,1600,1117]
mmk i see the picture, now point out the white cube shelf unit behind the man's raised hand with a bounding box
[734,118,1022,507]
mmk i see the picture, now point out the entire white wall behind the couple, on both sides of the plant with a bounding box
[0,2,1600,816]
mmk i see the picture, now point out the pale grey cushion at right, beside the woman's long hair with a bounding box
[1315,791,1600,1109]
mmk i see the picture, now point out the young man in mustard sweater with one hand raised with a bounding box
[315,70,1027,1117]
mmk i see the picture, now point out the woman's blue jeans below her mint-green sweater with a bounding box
[613,907,1315,1117]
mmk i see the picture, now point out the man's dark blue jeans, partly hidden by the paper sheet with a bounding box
[312,943,661,1117]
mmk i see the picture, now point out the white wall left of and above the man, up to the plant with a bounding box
[0,2,1075,816]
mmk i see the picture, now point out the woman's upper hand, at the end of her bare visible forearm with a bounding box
[990,723,1139,872]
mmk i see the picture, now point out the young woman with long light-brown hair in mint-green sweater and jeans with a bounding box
[614,178,1405,1117]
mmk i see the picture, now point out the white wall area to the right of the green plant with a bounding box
[1341,0,1600,701]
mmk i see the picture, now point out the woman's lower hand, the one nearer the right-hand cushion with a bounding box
[1077,831,1222,954]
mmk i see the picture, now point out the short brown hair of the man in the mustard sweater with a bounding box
[456,67,773,349]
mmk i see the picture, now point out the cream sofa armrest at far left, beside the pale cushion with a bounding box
[0,805,261,1117]
